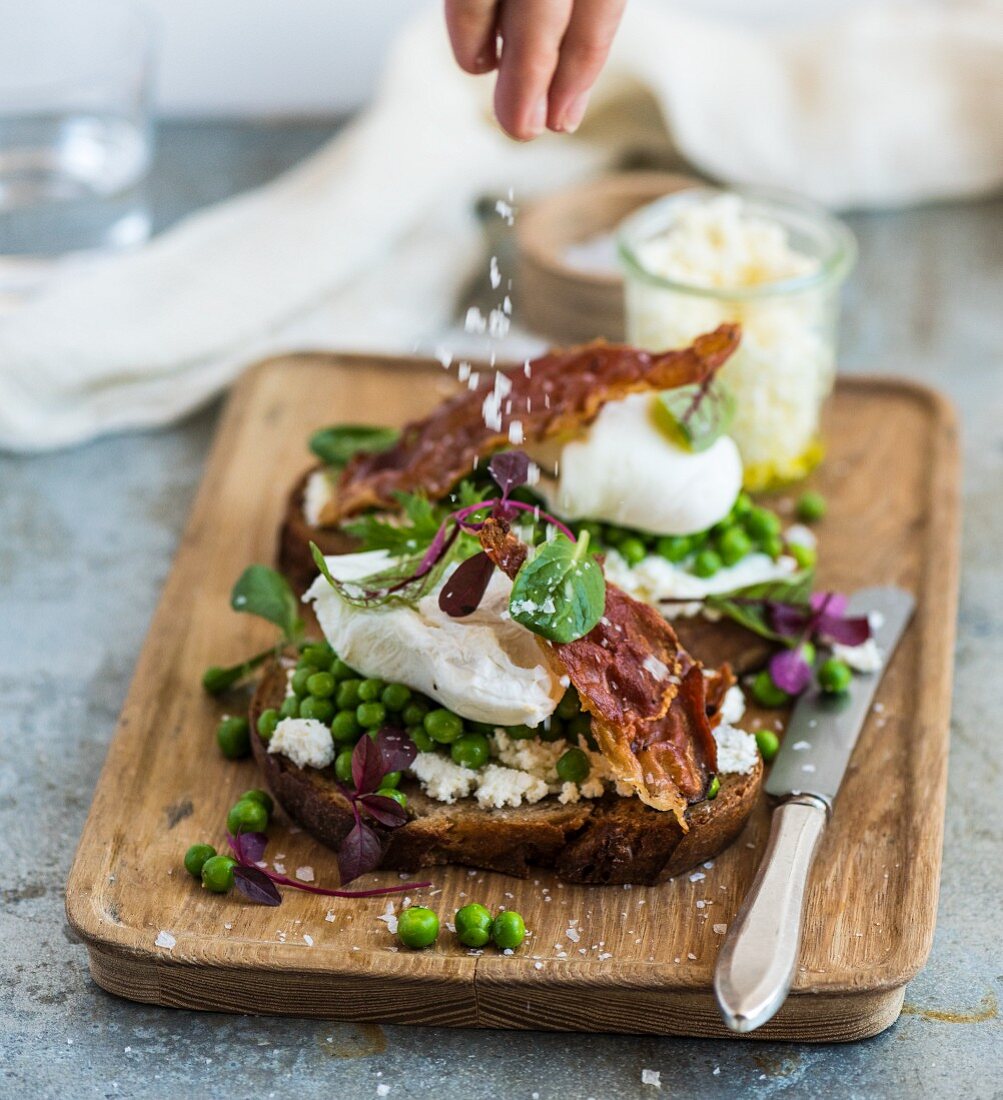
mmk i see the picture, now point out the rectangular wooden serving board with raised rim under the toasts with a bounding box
[66,354,958,1042]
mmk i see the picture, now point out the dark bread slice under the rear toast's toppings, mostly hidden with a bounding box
[276,466,773,677]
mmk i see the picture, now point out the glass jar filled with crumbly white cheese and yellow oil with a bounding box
[618,187,857,490]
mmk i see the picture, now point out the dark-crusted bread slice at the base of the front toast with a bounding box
[251,664,762,886]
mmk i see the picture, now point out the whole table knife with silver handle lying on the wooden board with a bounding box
[714,587,915,1032]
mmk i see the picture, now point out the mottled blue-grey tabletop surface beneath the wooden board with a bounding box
[0,123,1003,1100]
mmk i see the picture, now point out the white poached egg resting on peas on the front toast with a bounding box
[304,550,564,727]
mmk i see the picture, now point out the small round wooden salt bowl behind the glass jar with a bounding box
[516,172,698,344]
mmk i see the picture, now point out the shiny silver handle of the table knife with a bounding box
[714,794,828,1032]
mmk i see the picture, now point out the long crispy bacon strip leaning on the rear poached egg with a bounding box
[321,325,739,525]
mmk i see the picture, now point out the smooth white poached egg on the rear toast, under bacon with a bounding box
[537,394,742,535]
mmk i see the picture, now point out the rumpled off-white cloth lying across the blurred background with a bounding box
[0,0,1003,451]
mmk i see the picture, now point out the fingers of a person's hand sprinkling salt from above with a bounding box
[445,0,627,141]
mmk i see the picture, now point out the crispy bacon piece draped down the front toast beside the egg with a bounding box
[480,519,730,829]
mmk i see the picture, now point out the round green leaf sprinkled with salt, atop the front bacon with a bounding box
[508,531,606,642]
